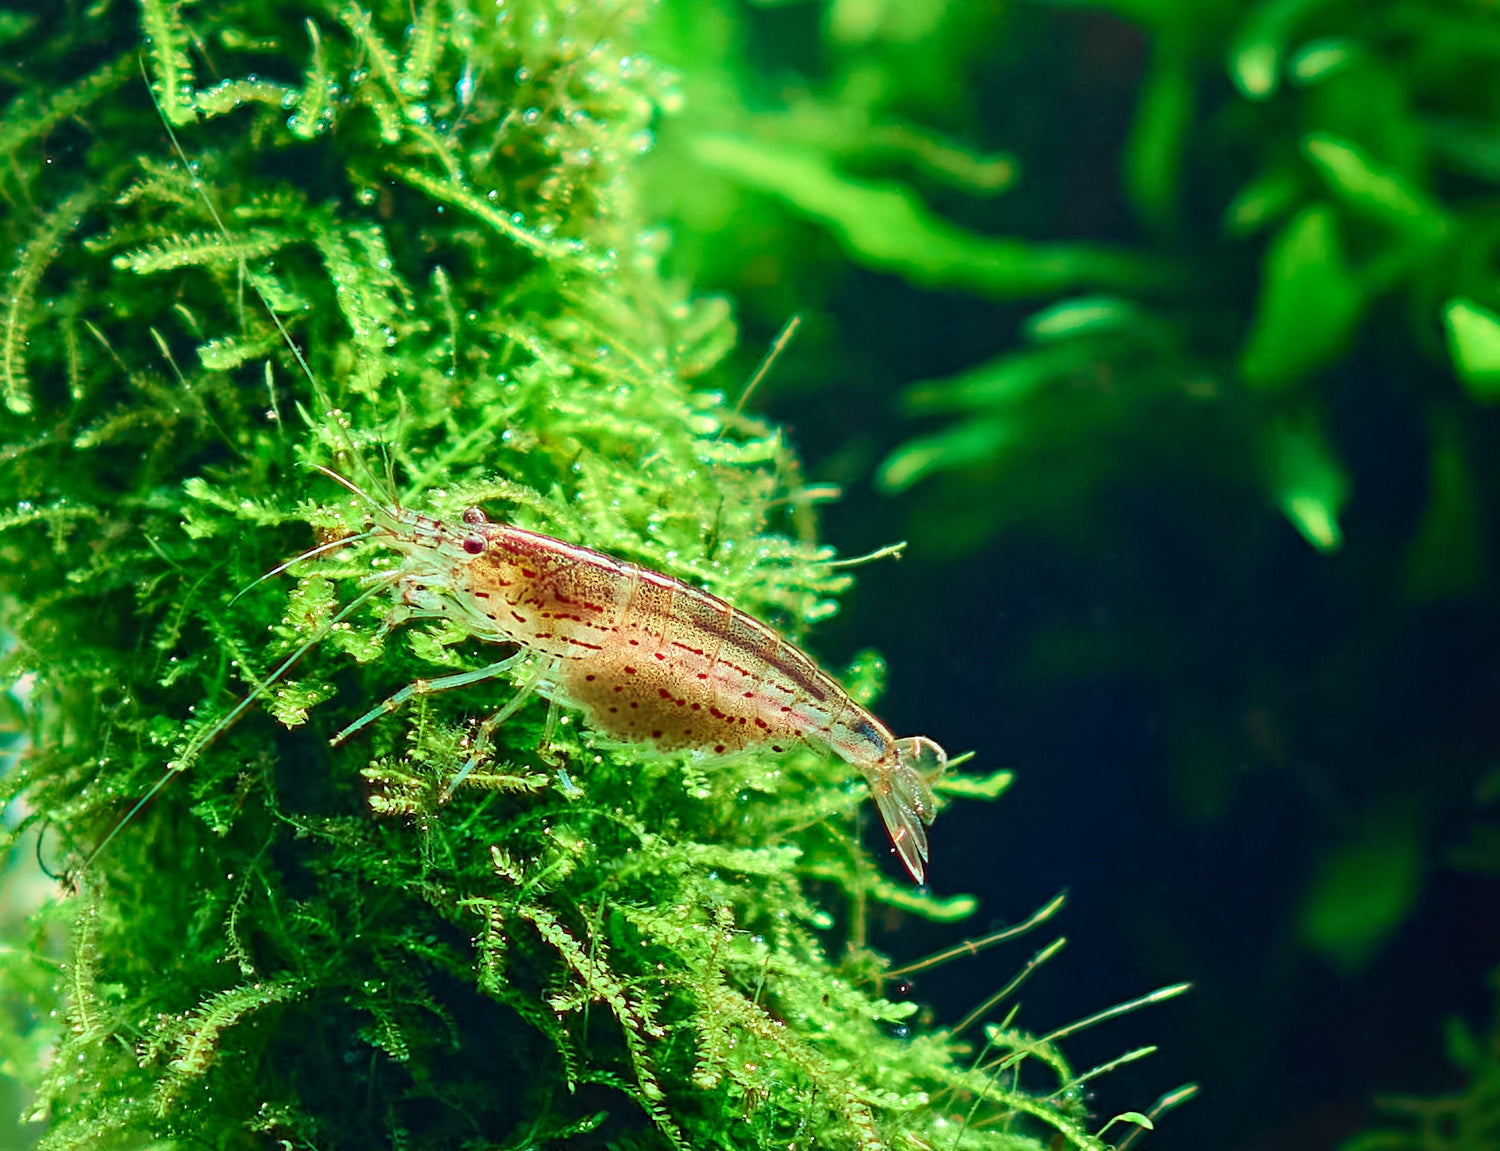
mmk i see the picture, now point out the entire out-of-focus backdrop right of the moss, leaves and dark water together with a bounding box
[639,0,1500,1146]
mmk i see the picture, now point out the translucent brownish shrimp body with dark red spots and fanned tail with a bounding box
[378,507,947,882]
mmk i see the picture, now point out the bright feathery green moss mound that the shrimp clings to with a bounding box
[0,0,1164,1148]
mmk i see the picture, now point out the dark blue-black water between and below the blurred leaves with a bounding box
[678,6,1500,1151]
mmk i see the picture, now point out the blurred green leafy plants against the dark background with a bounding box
[657,0,1500,966]
